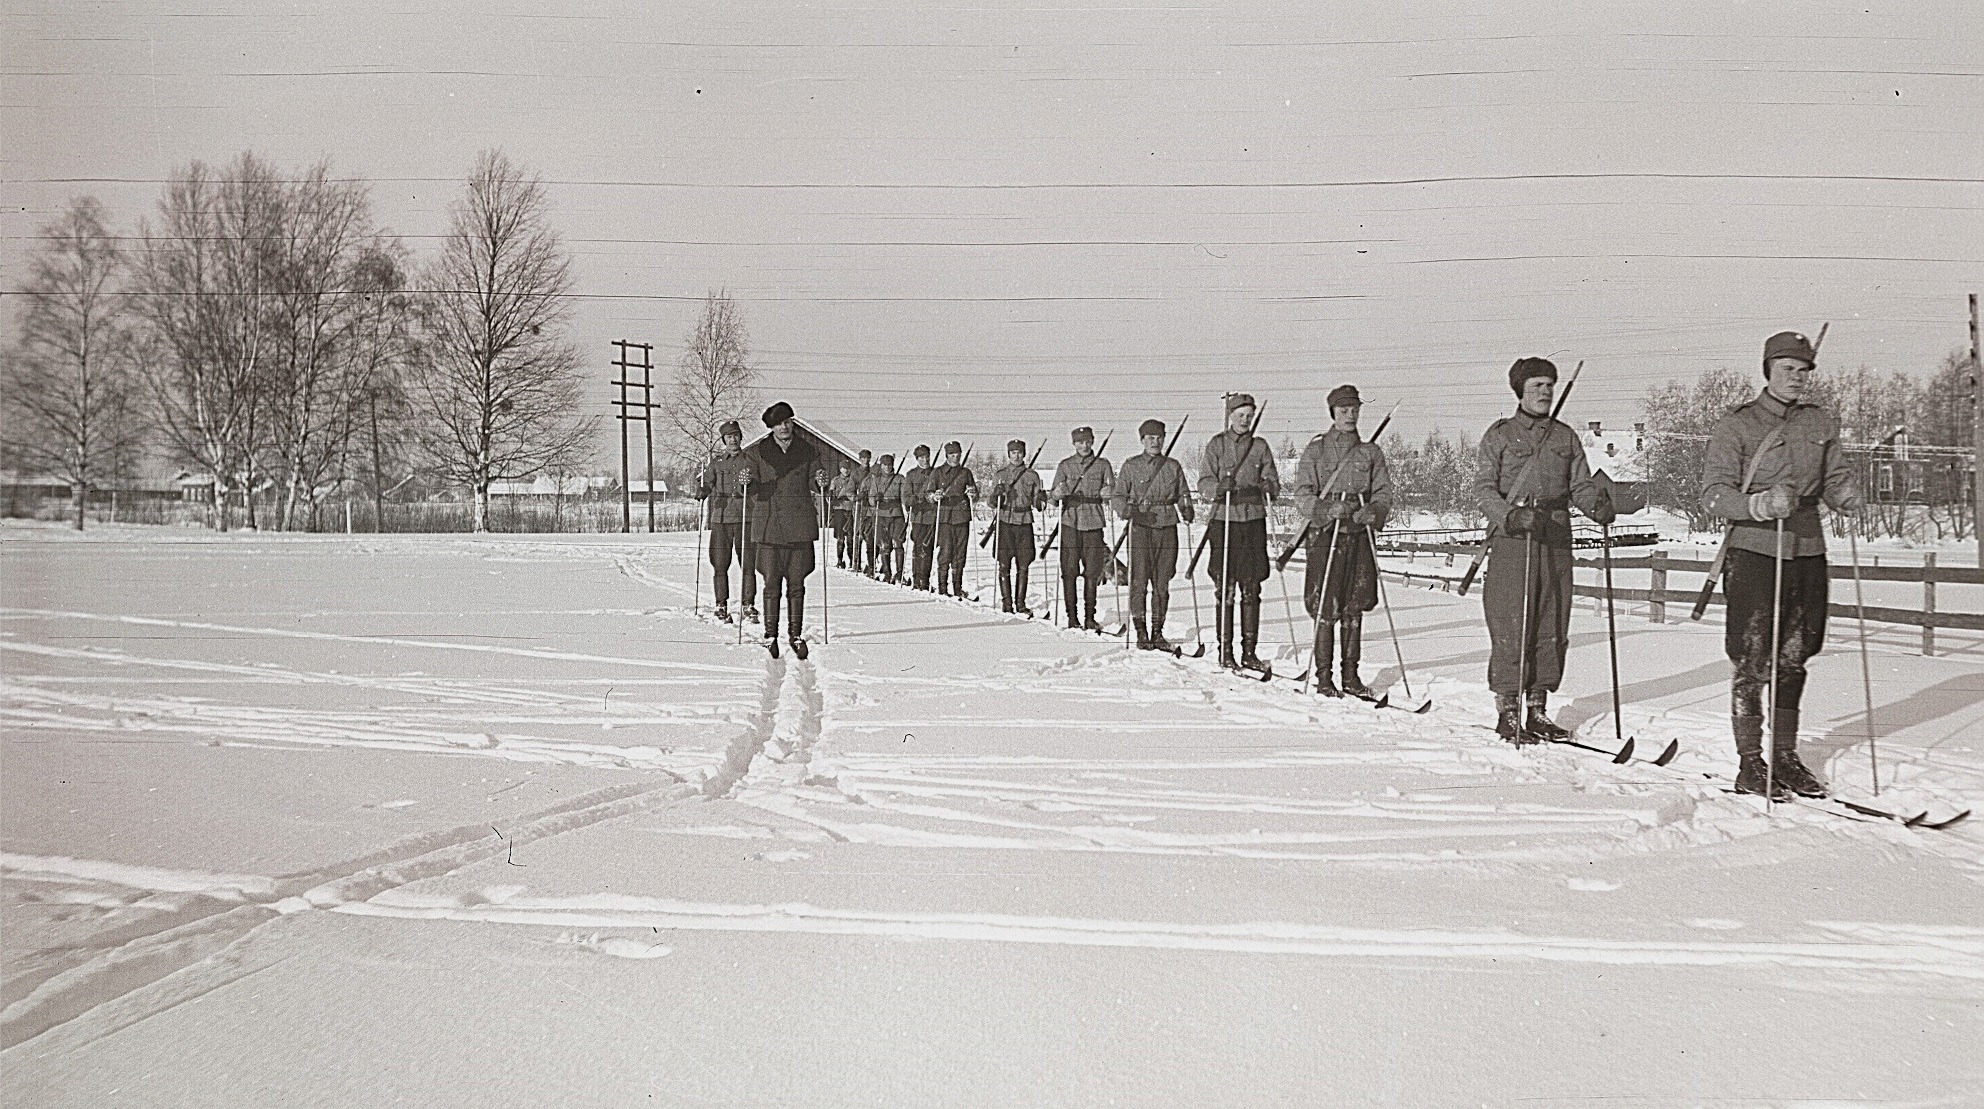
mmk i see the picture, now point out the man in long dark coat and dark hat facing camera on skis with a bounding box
[738,401,827,659]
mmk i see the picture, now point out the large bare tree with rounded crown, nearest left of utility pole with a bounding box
[409,151,595,532]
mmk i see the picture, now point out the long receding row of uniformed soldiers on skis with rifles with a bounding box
[700,331,1861,796]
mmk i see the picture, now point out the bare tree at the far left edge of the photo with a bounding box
[0,196,141,530]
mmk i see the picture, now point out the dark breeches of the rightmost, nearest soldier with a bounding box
[1722,550,1831,734]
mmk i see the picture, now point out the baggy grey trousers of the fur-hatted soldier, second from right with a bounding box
[1482,536,1571,692]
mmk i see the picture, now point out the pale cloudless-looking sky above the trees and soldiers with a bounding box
[0,0,1984,456]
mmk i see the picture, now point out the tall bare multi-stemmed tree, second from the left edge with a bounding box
[135,155,284,530]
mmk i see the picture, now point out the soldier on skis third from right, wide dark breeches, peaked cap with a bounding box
[1294,385,1391,698]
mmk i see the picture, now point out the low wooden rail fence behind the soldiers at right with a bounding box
[1379,536,1984,655]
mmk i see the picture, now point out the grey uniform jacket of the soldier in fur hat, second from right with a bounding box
[1474,411,1599,546]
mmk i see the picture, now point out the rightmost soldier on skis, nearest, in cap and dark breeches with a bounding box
[1702,331,1861,798]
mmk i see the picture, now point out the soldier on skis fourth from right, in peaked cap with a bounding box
[1198,393,1282,671]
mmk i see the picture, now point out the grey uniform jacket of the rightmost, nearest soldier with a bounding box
[1702,389,1859,557]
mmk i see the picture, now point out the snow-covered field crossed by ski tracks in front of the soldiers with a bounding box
[0,528,1984,1109]
